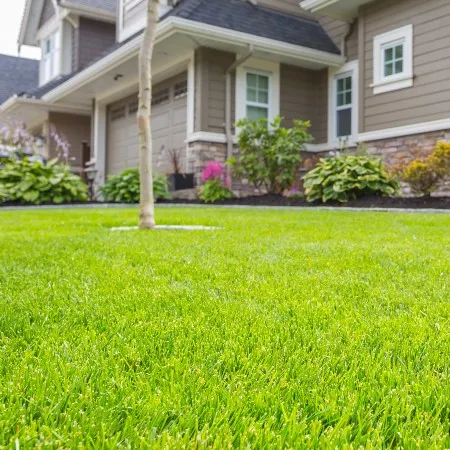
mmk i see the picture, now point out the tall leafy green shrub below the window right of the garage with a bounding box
[229,116,312,194]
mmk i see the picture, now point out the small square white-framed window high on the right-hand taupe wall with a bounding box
[372,25,413,94]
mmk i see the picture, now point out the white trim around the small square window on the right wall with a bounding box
[370,25,414,95]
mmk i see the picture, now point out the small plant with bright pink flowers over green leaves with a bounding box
[200,161,233,203]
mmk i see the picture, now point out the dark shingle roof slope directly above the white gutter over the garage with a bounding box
[166,0,340,54]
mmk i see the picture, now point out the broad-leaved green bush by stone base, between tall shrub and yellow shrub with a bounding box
[304,156,399,203]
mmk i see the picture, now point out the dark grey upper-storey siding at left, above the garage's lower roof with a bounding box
[77,17,116,70]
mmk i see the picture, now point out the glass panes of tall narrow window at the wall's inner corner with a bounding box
[336,73,353,138]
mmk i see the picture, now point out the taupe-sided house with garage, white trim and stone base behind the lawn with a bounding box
[1,0,450,192]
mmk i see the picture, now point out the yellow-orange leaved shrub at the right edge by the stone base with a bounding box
[400,142,450,196]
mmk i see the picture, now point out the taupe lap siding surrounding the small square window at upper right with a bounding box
[362,0,450,131]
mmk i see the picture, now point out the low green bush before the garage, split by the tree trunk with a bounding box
[100,169,171,203]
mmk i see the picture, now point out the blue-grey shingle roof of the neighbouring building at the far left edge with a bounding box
[0,55,39,104]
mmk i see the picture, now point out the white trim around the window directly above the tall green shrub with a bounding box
[236,55,280,122]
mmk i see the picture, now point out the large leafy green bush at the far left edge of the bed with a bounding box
[0,158,88,205]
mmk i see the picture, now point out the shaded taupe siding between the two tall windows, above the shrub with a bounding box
[280,64,328,144]
